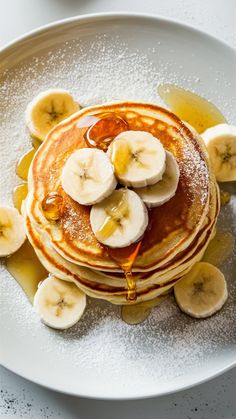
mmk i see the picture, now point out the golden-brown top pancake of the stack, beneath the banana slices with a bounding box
[27,102,210,271]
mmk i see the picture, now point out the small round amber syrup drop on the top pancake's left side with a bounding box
[41,192,63,221]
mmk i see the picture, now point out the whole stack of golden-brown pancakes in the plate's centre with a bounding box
[24,102,220,304]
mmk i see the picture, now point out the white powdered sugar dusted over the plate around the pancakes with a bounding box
[0,30,236,398]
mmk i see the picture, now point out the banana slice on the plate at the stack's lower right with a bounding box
[174,262,228,318]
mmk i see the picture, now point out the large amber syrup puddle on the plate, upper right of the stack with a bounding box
[157,83,227,134]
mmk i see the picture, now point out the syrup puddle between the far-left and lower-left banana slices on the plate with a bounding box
[6,240,48,303]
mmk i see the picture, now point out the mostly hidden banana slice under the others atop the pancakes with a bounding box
[135,151,179,208]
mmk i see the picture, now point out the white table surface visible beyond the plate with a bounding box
[0,0,236,419]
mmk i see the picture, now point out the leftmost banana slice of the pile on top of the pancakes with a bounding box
[61,148,117,205]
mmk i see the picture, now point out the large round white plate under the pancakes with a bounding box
[0,14,236,399]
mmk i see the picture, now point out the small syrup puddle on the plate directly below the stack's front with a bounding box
[121,295,168,325]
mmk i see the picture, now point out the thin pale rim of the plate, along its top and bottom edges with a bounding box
[0,11,236,401]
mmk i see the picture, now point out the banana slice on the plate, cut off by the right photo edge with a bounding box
[201,124,236,182]
